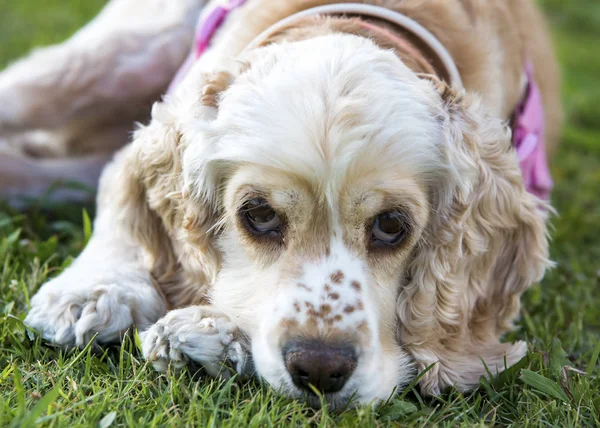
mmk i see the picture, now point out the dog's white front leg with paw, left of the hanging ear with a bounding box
[25,146,168,346]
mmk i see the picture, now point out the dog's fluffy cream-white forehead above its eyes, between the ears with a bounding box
[213,37,442,193]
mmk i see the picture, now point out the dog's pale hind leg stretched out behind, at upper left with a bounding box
[0,0,205,136]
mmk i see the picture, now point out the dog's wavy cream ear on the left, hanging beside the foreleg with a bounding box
[149,62,246,305]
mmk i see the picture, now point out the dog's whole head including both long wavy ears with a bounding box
[129,35,548,405]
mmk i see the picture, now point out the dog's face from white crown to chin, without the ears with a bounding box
[185,37,442,402]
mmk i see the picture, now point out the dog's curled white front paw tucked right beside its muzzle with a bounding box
[140,306,247,378]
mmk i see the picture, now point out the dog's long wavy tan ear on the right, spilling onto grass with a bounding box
[398,82,551,395]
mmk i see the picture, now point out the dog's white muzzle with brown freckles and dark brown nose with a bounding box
[252,241,405,408]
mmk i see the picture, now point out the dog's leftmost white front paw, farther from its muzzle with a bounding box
[25,277,165,347]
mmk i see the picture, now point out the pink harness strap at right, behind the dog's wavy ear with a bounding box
[513,63,553,199]
